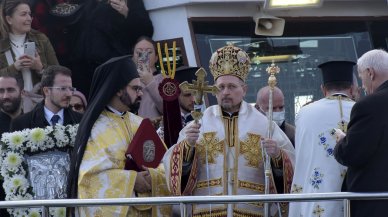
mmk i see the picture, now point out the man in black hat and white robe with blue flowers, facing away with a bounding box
[289,61,355,217]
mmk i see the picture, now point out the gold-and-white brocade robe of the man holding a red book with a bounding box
[78,111,171,217]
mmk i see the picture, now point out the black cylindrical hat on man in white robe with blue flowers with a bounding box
[318,61,356,84]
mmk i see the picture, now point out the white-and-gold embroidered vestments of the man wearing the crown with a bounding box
[165,103,295,217]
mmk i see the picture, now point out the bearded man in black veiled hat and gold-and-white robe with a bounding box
[70,56,170,217]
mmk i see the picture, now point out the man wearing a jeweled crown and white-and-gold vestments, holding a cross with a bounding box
[163,45,294,217]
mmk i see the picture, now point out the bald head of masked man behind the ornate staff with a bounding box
[256,86,284,112]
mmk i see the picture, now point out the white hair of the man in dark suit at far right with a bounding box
[357,49,388,75]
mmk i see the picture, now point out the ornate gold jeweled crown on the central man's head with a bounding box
[209,44,251,81]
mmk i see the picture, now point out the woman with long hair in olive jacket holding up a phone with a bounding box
[0,0,58,91]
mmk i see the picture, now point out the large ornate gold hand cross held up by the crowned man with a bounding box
[179,68,218,122]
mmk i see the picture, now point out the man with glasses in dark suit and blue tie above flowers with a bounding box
[11,66,82,131]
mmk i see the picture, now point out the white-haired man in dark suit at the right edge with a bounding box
[334,50,388,217]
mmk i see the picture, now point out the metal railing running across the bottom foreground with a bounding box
[0,192,388,217]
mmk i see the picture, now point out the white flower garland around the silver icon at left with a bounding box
[0,124,78,217]
